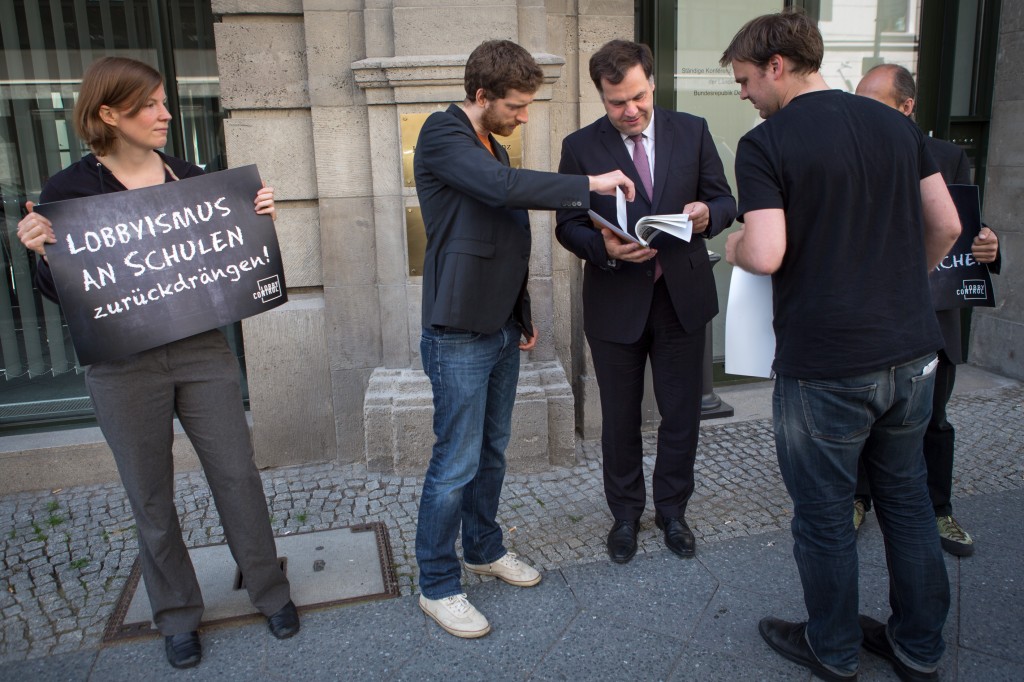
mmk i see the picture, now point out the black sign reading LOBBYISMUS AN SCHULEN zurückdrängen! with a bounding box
[35,166,288,365]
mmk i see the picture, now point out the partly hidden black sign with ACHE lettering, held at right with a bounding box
[928,184,995,310]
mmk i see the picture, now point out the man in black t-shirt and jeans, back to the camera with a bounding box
[721,12,959,680]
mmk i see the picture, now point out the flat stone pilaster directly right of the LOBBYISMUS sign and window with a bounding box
[213,0,337,467]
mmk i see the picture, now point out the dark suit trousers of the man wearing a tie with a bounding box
[587,278,705,521]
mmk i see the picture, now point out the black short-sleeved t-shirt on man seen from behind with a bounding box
[736,90,942,379]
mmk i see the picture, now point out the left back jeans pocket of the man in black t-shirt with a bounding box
[800,380,878,442]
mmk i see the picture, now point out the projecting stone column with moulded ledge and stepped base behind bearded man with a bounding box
[352,53,575,473]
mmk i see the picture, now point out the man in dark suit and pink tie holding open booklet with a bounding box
[555,40,736,563]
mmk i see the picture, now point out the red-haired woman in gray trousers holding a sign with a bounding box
[17,57,299,668]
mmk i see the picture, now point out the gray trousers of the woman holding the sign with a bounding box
[85,331,291,636]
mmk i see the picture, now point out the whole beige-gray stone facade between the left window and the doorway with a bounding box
[206,0,633,471]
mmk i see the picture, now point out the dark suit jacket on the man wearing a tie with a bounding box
[555,108,736,343]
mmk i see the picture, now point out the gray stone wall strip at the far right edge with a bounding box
[971,0,1024,379]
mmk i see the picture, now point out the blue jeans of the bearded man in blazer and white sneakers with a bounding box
[416,322,520,599]
